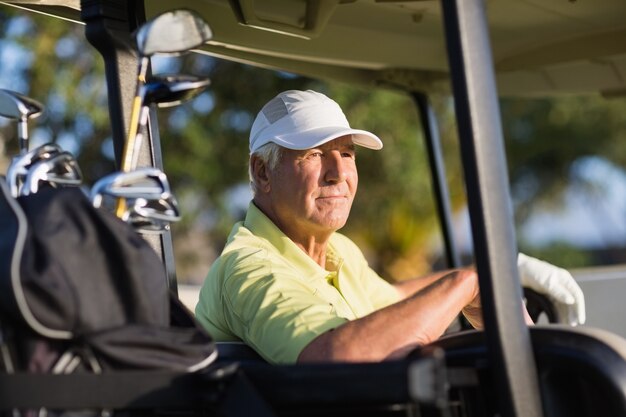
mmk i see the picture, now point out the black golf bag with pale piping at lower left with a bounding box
[0,177,217,410]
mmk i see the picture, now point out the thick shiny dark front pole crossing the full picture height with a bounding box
[441,0,543,417]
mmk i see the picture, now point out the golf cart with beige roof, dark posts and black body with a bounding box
[1,0,626,416]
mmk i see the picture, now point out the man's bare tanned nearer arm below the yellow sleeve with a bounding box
[298,270,478,363]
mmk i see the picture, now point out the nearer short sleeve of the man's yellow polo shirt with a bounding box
[222,250,347,363]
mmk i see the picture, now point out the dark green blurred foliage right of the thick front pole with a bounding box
[502,95,626,223]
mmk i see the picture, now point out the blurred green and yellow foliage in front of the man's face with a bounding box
[328,84,464,279]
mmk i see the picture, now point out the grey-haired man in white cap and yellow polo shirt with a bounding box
[196,90,584,363]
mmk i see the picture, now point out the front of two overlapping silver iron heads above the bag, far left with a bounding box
[19,151,83,195]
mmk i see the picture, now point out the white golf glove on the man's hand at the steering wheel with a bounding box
[517,253,586,326]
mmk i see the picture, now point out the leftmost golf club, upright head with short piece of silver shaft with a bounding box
[0,89,43,153]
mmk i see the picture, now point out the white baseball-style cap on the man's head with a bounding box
[250,90,383,153]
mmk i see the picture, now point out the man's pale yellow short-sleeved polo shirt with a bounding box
[196,203,400,363]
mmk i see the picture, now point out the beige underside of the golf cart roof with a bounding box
[3,0,626,95]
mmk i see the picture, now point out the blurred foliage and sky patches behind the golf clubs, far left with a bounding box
[0,6,114,181]
